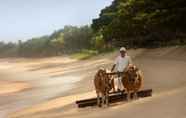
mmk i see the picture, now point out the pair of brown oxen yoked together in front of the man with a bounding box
[94,65,143,107]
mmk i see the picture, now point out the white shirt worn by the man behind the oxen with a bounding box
[114,55,132,72]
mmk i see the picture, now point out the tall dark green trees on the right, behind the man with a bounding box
[92,0,186,48]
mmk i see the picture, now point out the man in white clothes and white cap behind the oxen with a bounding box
[111,47,132,91]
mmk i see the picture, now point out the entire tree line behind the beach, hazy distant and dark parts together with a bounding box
[0,0,186,57]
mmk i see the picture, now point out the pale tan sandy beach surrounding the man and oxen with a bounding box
[0,47,186,118]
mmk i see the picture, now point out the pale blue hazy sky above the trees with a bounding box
[0,0,113,41]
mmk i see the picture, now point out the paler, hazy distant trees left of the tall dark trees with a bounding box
[0,26,94,57]
